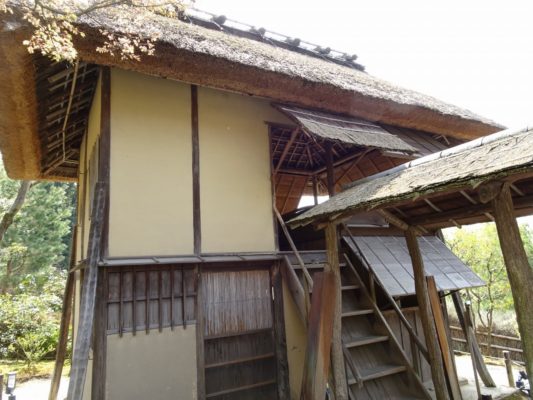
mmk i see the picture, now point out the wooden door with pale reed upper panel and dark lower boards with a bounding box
[202,269,278,400]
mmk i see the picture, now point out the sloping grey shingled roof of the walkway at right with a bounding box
[289,128,533,230]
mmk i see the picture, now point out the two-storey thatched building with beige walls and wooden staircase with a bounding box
[0,6,528,400]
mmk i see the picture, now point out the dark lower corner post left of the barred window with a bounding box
[91,268,107,400]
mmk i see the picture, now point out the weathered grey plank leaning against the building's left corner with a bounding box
[67,182,107,400]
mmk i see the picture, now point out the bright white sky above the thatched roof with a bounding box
[195,0,533,225]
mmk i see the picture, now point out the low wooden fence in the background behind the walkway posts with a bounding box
[450,326,524,363]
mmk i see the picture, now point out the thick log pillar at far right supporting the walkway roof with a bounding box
[492,183,533,382]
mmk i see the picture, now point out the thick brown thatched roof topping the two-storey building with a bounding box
[0,5,501,179]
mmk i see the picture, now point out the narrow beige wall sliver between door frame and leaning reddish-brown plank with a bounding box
[283,281,307,400]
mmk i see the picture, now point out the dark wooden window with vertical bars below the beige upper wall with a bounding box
[106,265,197,335]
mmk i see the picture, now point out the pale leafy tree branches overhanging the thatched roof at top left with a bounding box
[0,0,189,61]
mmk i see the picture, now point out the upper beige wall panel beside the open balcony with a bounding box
[198,88,287,253]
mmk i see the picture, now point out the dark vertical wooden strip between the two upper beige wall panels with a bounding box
[191,85,202,255]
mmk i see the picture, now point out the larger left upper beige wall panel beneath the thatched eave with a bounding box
[109,69,193,256]
